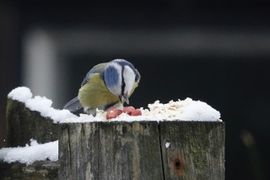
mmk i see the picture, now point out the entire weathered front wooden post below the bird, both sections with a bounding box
[59,121,225,180]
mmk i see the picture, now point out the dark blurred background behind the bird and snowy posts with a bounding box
[0,0,270,180]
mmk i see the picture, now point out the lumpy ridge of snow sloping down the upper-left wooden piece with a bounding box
[8,87,77,123]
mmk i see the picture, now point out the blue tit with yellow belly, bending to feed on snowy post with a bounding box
[64,59,141,114]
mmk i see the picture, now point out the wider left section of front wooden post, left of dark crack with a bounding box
[59,122,163,180]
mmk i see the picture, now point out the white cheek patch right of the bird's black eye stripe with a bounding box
[123,66,135,96]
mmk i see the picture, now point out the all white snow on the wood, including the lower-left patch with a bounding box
[0,87,221,165]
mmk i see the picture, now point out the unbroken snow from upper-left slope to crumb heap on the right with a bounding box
[8,87,221,123]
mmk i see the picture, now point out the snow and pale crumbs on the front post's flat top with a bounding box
[61,98,221,123]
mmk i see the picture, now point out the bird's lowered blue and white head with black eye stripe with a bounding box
[103,59,141,104]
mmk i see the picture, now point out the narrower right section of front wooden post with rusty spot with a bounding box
[160,121,225,180]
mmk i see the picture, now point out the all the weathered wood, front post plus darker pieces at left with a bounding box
[3,99,225,180]
